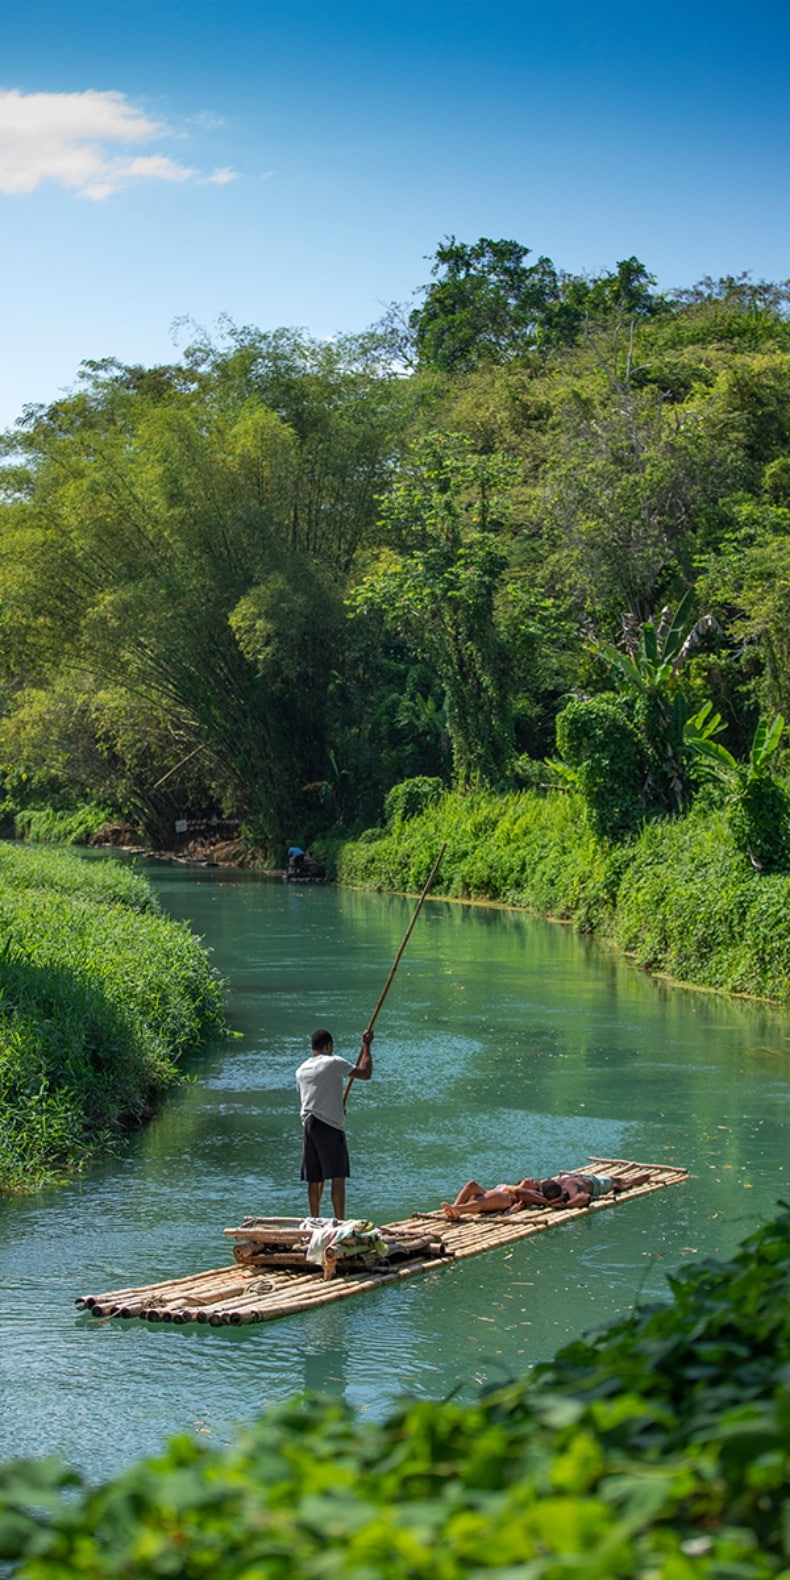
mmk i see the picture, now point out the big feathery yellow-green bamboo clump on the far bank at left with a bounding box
[0,332,400,837]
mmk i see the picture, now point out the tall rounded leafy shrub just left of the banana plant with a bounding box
[556,695,645,839]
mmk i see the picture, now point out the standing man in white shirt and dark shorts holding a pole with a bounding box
[295,1029,373,1220]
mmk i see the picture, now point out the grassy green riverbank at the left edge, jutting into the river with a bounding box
[0,845,229,1191]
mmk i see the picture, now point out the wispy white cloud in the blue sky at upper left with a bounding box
[0,88,234,202]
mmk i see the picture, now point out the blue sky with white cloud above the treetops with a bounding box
[0,0,790,428]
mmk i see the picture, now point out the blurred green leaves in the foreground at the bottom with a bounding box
[0,1212,790,1580]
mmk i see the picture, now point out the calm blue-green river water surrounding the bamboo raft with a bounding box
[0,863,790,1480]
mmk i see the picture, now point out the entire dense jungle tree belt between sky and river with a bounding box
[0,239,790,872]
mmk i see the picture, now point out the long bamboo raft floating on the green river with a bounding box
[76,1158,689,1327]
